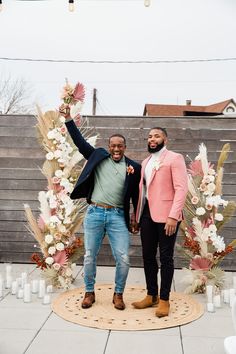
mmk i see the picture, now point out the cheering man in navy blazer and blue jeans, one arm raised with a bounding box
[60,108,141,310]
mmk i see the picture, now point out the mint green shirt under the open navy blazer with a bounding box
[91,157,126,208]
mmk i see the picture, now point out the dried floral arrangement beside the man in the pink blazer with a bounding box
[181,144,236,293]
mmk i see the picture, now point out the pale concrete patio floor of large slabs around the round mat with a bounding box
[0,264,235,354]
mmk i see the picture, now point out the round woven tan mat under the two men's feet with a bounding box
[52,284,204,331]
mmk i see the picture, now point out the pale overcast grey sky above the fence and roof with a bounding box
[0,0,236,115]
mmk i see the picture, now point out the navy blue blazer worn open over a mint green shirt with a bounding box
[66,120,141,229]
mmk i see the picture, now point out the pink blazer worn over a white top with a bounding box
[136,149,188,223]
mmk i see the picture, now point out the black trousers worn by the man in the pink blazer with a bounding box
[140,202,180,300]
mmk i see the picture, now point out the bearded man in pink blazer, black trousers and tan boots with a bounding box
[132,127,188,317]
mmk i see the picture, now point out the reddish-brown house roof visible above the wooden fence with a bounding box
[143,99,236,116]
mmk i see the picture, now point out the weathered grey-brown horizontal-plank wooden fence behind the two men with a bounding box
[0,115,236,270]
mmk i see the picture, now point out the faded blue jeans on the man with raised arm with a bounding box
[84,205,129,293]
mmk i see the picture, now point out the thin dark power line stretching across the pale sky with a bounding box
[0,57,236,64]
